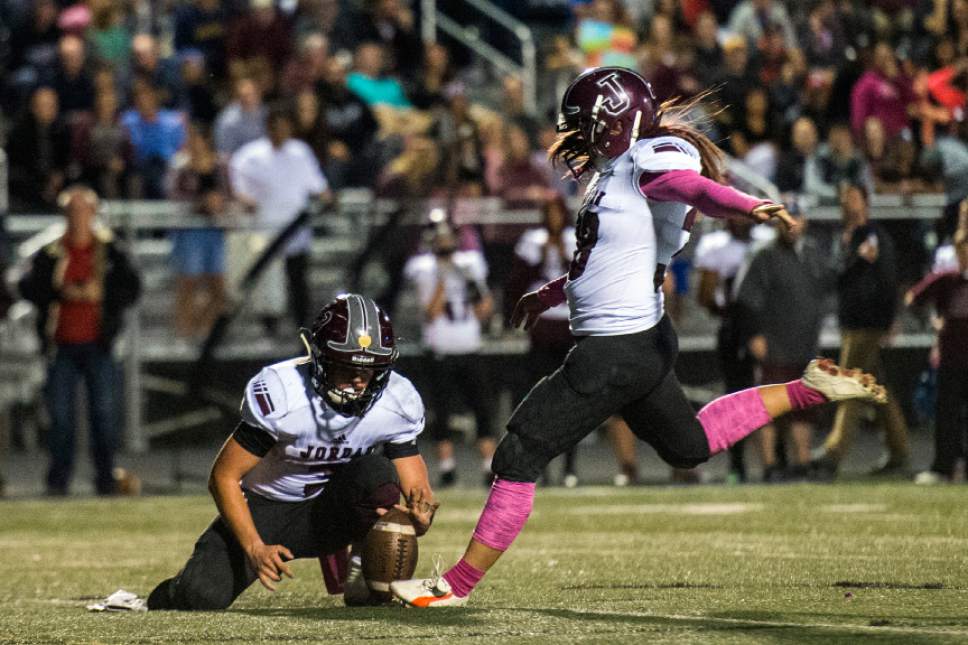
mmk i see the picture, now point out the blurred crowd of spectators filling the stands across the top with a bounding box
[0,0,968,218]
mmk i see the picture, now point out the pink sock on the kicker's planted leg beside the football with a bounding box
[444,478,535,597]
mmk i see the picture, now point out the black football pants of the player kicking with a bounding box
[493,316,709,482]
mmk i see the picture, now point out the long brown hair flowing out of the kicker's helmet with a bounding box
[548,90,726,181]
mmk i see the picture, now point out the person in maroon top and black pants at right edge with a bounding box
[904,218,968,484]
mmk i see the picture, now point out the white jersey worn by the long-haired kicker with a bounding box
[565,136,702,336]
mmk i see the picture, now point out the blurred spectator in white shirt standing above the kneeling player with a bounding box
[229,107,330,331]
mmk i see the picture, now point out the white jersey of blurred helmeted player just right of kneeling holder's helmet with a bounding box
[403,251,488,354]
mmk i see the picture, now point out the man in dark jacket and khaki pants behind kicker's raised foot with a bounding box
[815,185,909,476]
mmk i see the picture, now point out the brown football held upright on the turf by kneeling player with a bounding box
[363,509,417,601]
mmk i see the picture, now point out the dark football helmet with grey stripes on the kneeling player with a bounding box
[302,293,399,416]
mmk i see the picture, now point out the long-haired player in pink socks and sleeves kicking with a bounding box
[390,67,886,607]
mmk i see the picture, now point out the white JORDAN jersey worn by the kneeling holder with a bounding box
[242,358,424,502]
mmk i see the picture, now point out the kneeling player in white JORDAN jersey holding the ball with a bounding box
[93,294,438,610]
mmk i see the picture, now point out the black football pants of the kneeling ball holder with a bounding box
[148,455,400,610]
